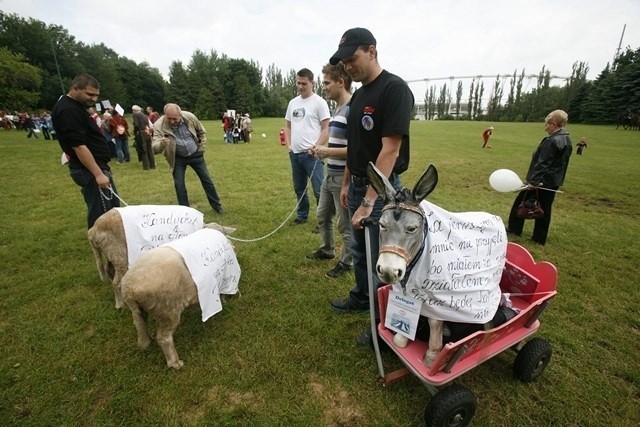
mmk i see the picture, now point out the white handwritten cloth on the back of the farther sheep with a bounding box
[115,205,204,267]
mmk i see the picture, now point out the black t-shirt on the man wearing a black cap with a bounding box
[347,70,414,177]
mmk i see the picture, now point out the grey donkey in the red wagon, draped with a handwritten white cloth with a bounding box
[367,163,507,367]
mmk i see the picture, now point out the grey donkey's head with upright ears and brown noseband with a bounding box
[367,162,438,283]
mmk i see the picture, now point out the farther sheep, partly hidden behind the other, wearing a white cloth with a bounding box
[87,205,235,309]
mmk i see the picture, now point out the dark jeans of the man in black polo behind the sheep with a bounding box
[69,168,120,228]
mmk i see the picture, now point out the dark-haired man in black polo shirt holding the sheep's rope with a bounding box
[51,73,120,228]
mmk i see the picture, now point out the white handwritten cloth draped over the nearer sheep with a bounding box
[164,228,240,322]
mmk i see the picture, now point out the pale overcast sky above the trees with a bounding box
[0,0,640,101]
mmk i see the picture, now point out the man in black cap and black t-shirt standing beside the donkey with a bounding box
[329,28,414,345]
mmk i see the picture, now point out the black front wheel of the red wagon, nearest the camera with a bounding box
[424,384,477,427]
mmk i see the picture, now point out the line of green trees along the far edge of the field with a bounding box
[0,11,640,124]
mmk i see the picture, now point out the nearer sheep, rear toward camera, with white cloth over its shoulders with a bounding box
[121,229,240,369]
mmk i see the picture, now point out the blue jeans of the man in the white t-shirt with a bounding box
[289,151,324,221]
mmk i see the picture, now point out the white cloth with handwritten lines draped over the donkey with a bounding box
[406,200,507,323]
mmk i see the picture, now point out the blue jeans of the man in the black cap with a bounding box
[347,175,402,320]
